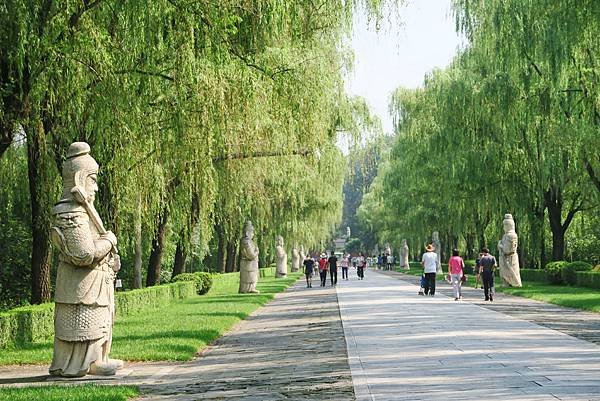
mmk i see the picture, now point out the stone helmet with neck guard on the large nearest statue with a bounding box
[62,142,98,198]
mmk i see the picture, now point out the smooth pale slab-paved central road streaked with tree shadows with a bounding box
[338,271,600,401]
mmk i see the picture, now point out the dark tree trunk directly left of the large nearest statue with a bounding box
[27,121,52,304]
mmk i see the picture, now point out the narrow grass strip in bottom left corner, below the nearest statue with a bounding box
[0,384,139,401]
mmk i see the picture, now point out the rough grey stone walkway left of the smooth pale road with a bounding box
[0,280,354,401]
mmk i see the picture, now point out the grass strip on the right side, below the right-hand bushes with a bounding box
[496,282,600,312]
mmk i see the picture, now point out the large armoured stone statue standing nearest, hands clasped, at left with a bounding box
[49,142,123,377]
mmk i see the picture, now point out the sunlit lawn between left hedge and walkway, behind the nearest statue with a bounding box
[0,273,300,365]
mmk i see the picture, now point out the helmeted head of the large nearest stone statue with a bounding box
[62,142,98,203]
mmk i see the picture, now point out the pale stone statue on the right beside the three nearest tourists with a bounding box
[498,214,522,287]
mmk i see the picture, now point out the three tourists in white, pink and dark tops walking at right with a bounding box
[419,244,497,301]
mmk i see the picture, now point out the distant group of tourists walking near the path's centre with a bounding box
[302,252,367,288]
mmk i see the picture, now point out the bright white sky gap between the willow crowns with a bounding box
[346,0,464,133]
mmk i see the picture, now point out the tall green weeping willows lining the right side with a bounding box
[363,0,600,266]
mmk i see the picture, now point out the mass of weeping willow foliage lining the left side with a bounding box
[0,0,399,303]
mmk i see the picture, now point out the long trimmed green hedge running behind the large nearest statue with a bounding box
[0,281,196,348]
